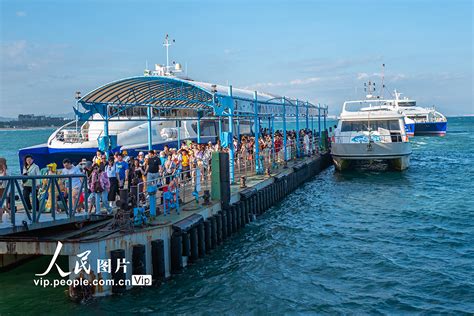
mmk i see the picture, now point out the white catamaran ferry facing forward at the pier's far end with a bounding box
[331,100,412,171]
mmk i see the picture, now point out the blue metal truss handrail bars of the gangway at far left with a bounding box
[0,174,88,226]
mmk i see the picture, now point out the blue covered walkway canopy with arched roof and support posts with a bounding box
[75,76,327,179]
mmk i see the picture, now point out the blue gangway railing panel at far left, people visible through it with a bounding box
[0,175,88,226]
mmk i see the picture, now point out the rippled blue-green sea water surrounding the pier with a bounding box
[0,118,474,315]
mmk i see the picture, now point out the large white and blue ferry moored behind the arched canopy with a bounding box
[19,37,258,167]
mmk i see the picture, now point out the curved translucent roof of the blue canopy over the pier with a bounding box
[76,76,324,118]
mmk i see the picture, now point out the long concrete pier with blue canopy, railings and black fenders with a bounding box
[0,76,331,300]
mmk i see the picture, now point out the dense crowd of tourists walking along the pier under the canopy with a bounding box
[0,129,317,214]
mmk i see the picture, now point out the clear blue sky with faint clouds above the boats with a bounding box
[0,0,474,117]
